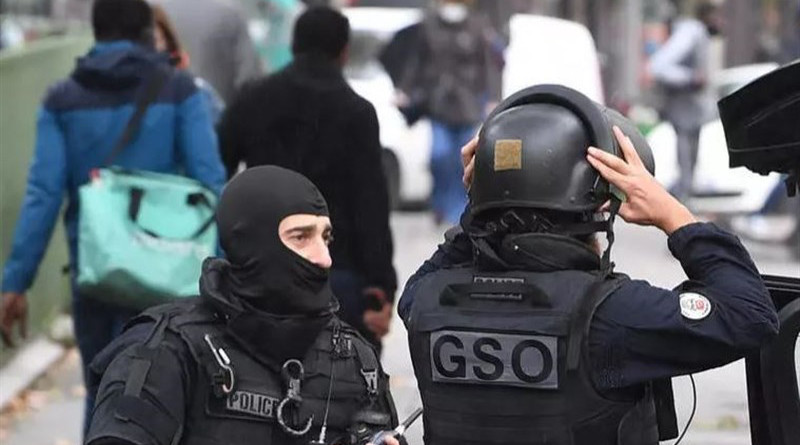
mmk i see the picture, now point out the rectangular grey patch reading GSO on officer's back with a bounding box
[430,331,558,389]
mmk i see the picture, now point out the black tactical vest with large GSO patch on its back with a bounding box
[407,268,658,445]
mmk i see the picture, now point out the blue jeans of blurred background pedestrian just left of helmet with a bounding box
[431,120,475,224]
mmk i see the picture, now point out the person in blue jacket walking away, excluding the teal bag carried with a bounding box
[0,0,225,434]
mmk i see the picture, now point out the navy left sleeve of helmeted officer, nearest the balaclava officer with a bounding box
[397,226,472,322]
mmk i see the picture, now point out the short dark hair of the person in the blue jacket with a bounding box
[92,0,153,42]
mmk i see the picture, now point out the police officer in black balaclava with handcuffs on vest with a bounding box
[86,166,396,445]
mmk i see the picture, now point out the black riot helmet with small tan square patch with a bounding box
[469,85,655,216]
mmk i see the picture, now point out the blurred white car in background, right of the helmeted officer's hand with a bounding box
[647,63,780,215]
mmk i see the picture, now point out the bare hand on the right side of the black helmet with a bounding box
[586,126,695,235]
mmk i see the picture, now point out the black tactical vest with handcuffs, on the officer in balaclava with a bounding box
[126,304,396,445]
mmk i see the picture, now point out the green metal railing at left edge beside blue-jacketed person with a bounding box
[0,35,92,364]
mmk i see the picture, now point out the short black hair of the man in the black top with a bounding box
[292,6,350,59]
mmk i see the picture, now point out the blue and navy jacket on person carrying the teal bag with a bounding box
[2,41,225,292]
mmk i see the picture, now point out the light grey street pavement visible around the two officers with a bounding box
[0,213,800,445]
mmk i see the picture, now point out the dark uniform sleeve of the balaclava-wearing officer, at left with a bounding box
[86,333,194,445]
